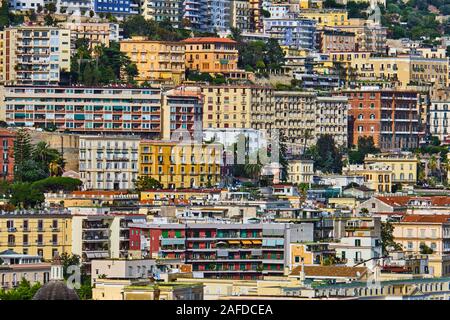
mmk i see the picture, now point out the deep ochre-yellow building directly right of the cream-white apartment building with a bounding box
[139,140,221,189]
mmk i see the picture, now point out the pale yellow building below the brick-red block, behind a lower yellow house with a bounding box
[364,153,419,185]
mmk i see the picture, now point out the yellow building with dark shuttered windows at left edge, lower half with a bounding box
[0,212,72,261]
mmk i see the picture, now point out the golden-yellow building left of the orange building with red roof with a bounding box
[120,37,185,84]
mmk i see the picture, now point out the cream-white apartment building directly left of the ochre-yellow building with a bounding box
[79,136,140,190]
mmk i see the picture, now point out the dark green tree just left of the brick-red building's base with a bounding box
[306,134,342,173]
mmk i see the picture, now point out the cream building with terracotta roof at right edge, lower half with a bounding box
[392,214,450,277]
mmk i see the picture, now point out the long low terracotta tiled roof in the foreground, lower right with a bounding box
[291,266,367,279]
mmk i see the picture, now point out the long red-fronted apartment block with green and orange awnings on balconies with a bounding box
[130,222,313,280]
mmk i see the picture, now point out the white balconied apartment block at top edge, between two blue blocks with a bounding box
[141,0,184,28]
